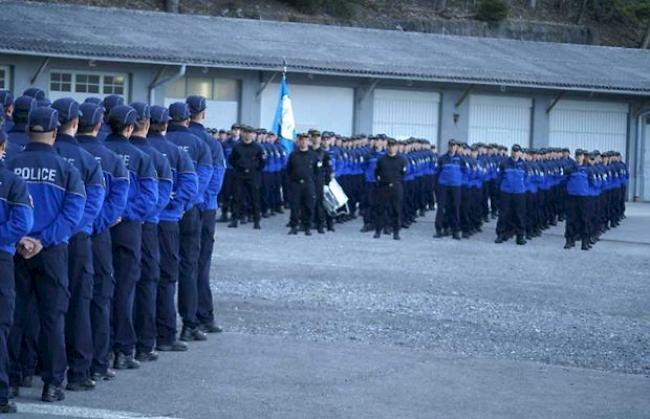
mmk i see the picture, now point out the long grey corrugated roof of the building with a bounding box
[0,0,650,95]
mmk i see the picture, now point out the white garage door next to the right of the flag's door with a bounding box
[372,89,440,144]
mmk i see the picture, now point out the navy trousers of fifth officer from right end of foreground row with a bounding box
[111,221,142,355]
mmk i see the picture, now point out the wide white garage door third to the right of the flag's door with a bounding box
[549,100,629,159]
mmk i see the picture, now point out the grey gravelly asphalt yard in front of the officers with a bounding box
[12,204,650,419]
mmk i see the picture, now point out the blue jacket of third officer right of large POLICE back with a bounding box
[104,134,158,221]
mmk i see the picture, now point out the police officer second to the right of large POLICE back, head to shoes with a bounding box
[77,102,129,381]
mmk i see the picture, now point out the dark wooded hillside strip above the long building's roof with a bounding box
[31,0,650,48]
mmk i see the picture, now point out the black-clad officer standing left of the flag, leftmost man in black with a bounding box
[228,125,265,230]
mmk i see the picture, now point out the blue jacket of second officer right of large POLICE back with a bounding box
[77,135,129,234]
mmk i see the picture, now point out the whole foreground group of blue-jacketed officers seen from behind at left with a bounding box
[0,88,225,413]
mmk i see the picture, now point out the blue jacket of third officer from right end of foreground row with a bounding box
[147,133,199,222]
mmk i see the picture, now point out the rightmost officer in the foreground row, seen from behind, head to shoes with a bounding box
[186,96,226,333]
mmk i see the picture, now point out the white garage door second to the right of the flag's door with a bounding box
[467,95,533,147]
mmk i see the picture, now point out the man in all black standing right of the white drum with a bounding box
[374,138,407,240]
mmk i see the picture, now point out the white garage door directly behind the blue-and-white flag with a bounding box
[261,83,354,136]
